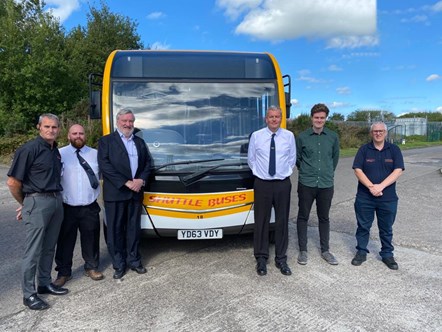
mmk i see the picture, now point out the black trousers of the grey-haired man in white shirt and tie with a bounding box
[253,178,292,263]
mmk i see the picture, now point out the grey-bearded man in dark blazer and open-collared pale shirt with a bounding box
[98,108,151,279]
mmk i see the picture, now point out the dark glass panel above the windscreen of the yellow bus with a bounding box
[110,50,277,80]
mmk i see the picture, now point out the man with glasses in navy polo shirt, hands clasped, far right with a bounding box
[351,122,405,270]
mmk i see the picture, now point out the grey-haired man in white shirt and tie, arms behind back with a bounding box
[248,106,296,276]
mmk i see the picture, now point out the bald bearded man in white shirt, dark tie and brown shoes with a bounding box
[54,124,104,286]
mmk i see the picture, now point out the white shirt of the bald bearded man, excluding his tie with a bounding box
[60,144,100,206]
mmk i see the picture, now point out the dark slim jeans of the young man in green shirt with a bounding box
[296,182,334,252]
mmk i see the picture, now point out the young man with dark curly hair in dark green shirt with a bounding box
[296,104,339,265]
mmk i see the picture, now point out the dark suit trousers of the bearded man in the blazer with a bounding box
[104,199,141,270]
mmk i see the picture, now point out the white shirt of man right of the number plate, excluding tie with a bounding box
[247,127,296,180]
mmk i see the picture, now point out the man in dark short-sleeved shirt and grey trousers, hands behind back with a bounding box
[7,113,68,310]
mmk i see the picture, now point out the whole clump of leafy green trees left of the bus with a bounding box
[0,0,143,136]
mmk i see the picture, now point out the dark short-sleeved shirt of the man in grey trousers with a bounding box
[8,136,62,194]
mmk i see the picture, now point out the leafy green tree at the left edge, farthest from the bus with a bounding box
[0,0,72,135]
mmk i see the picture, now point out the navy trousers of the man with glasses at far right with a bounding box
[354,197,398,258]
